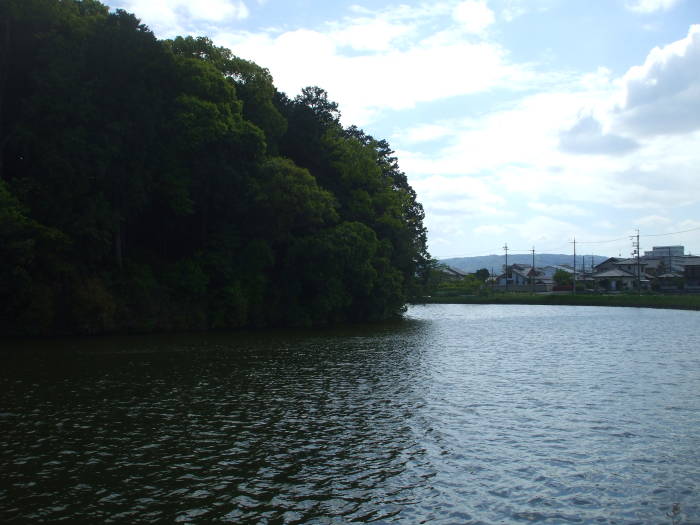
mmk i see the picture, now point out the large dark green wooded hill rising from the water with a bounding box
[0,0,428,335]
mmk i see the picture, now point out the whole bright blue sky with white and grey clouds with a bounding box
[100,0,700,258]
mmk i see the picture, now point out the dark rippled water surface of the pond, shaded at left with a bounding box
[0,305,700,524]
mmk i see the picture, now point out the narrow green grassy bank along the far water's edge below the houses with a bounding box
[414,293,700,310]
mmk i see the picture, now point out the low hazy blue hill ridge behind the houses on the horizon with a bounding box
[440,253,608,273]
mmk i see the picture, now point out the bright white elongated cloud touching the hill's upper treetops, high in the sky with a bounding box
[214,20,532,126]
